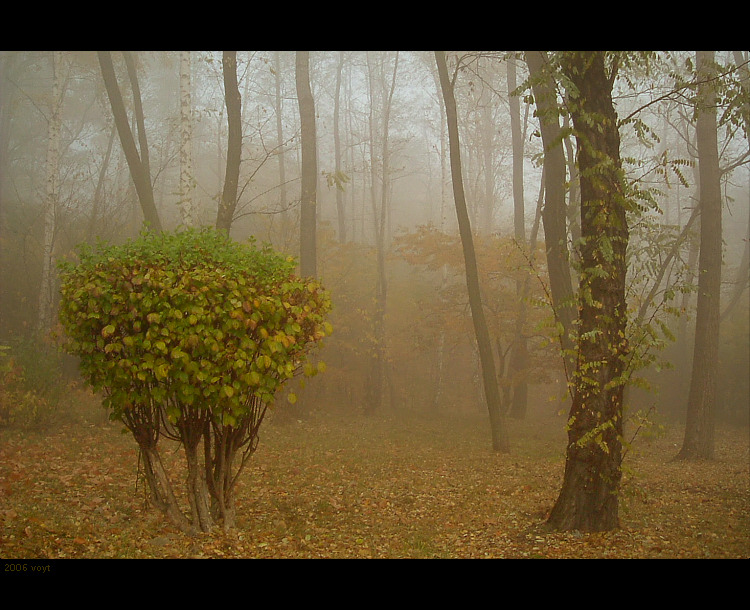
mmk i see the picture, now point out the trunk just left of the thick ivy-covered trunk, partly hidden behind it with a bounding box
[526,51,575,381]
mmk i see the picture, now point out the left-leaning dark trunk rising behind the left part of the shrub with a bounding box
[97,51,162,231]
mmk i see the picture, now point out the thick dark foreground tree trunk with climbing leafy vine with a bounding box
[548,52,628,531]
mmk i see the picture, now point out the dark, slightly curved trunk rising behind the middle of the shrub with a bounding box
[216,51,242,231]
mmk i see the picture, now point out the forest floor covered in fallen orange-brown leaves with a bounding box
[0,390,750,560]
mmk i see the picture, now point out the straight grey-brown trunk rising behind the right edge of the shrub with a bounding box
[295,51,318,277]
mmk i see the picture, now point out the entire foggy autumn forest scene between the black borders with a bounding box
[0,51,750,560]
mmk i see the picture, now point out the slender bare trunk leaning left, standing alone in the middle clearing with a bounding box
[435,51,510,453]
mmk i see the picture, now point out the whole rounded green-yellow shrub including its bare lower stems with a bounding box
[55,229,331,531]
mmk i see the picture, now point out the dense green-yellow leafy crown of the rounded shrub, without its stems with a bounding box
[60,229,331,425]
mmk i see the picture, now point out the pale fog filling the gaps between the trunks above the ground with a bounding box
[0,51,750,424]
